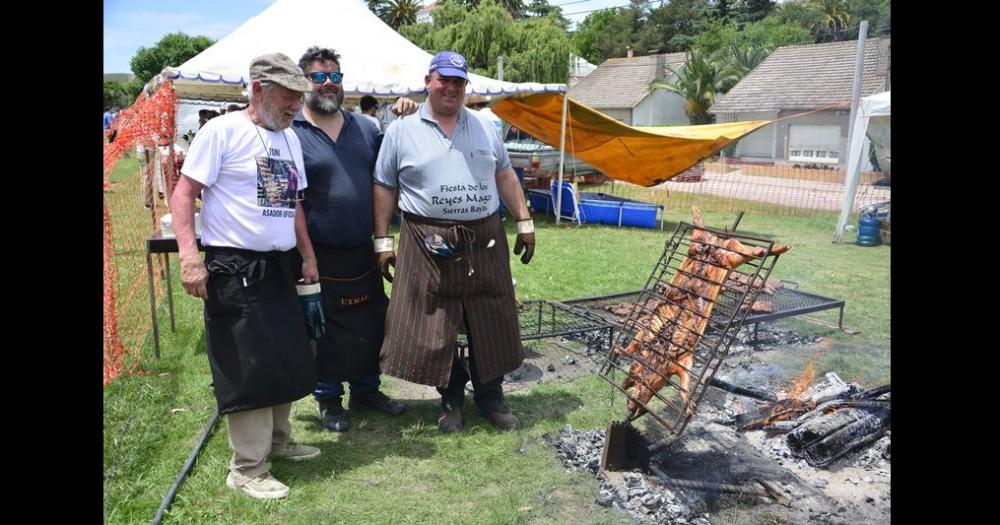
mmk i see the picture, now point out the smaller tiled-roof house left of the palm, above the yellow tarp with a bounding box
[569,52,688,126]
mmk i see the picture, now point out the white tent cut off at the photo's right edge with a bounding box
[835,91,891,242]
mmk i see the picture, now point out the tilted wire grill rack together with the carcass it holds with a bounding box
[592,222,777,442]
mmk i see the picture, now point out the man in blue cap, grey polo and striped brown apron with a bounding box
[373,51,535,432]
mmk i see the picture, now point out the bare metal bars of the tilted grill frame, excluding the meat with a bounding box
[592,222,778,442]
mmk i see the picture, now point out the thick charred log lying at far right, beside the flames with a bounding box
[786,402,891,467]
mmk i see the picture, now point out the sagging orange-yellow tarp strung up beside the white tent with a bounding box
[493,93,773,186]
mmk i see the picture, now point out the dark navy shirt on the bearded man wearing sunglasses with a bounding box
[292,111,381,248]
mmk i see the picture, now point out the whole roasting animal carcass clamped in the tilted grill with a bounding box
[614,206,789,419]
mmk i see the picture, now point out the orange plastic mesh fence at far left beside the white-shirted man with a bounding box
[104,83,176,386]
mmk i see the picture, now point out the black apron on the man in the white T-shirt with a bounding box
[205,247,316,414]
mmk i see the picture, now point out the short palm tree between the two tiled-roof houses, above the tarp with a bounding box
[649,49,723,124]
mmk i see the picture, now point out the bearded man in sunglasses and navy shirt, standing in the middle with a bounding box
[292,46,417,432]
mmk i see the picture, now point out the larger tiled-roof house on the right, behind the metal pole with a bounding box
[709,37,890,165]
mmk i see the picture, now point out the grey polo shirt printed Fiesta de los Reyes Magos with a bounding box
[375,103,510,221]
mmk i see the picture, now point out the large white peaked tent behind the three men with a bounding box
[161,0,566,100]
